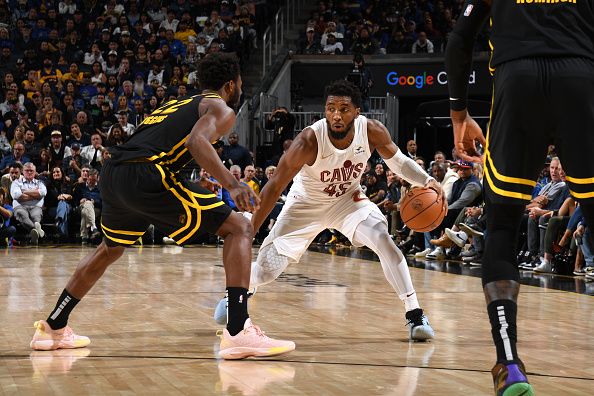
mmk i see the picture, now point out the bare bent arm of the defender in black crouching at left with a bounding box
[185,99,260,212]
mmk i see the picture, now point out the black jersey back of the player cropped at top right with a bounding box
[486,0,594,71]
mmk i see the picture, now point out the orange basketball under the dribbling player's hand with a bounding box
[400,188,447,232]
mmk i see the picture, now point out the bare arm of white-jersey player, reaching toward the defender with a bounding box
[252,128,318,231]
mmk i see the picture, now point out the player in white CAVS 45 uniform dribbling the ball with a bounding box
[215,80,445,341]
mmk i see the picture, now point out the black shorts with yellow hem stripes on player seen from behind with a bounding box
[483,58,594,203]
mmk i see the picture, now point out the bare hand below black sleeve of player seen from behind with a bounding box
[450,110,487,163]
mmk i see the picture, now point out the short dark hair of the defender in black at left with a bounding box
[197,52,239,91]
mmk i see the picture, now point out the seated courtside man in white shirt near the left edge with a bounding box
[10,162,47,245]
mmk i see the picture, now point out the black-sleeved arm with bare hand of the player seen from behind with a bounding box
[445,0,491,162]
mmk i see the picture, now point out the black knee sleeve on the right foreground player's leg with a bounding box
[482,202,525,286]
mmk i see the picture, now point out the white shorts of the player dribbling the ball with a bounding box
[262,194,388,261]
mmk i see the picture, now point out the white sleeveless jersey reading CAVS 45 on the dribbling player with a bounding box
[289,115,371,202]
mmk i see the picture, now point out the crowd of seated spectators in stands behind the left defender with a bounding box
[0,0,281,245]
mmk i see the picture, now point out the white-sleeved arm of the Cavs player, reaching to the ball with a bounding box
[367,119,445,205]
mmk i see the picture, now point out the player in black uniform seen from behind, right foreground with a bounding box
[446,0,594,396]
